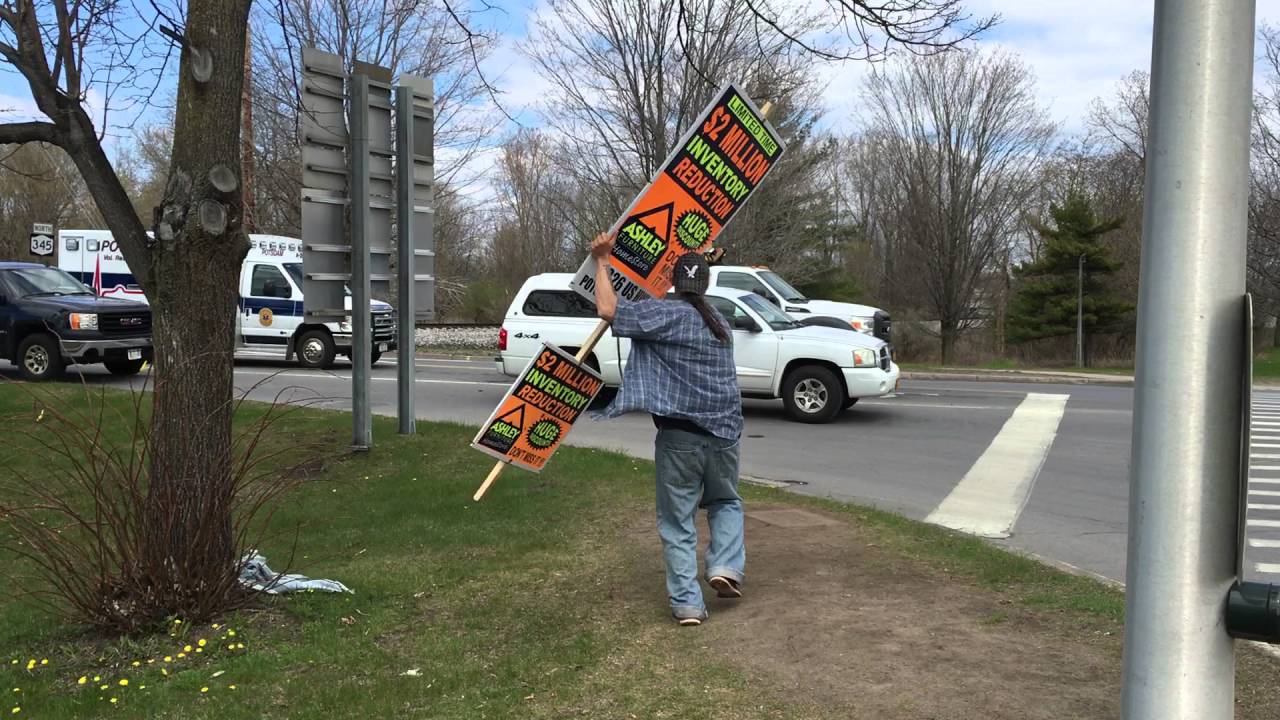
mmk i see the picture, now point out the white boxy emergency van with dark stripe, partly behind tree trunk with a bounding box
[58,229,397,368]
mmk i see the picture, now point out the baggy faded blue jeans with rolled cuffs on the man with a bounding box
[655,429,746,618]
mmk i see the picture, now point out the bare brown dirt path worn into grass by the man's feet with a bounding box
[588,506,1280,720]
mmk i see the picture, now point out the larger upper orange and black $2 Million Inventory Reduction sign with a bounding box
[573,83,783,301]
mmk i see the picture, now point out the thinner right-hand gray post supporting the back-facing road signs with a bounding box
[396,86,417,434]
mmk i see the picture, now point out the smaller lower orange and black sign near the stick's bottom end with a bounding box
[471,345,604,473]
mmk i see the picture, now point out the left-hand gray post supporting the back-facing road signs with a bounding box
[347,74,374,450]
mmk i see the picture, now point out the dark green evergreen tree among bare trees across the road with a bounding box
[1009,193,1133,364]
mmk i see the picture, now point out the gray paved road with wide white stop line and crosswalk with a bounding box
[0,359,1280,580]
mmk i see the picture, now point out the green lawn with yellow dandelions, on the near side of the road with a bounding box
[0,384,1182,719]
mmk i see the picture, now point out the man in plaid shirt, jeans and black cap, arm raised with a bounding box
[591,233,746,625]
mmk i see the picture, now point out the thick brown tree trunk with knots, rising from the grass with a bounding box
[145,0,250,591]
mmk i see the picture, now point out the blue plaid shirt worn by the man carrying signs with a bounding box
[599,297,742,439]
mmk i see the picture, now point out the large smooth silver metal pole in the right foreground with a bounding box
[1121,0,1254,720]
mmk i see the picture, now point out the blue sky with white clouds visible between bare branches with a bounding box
[0,0,1280,144]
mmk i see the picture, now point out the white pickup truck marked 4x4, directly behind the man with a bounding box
[497,273,899,423]
